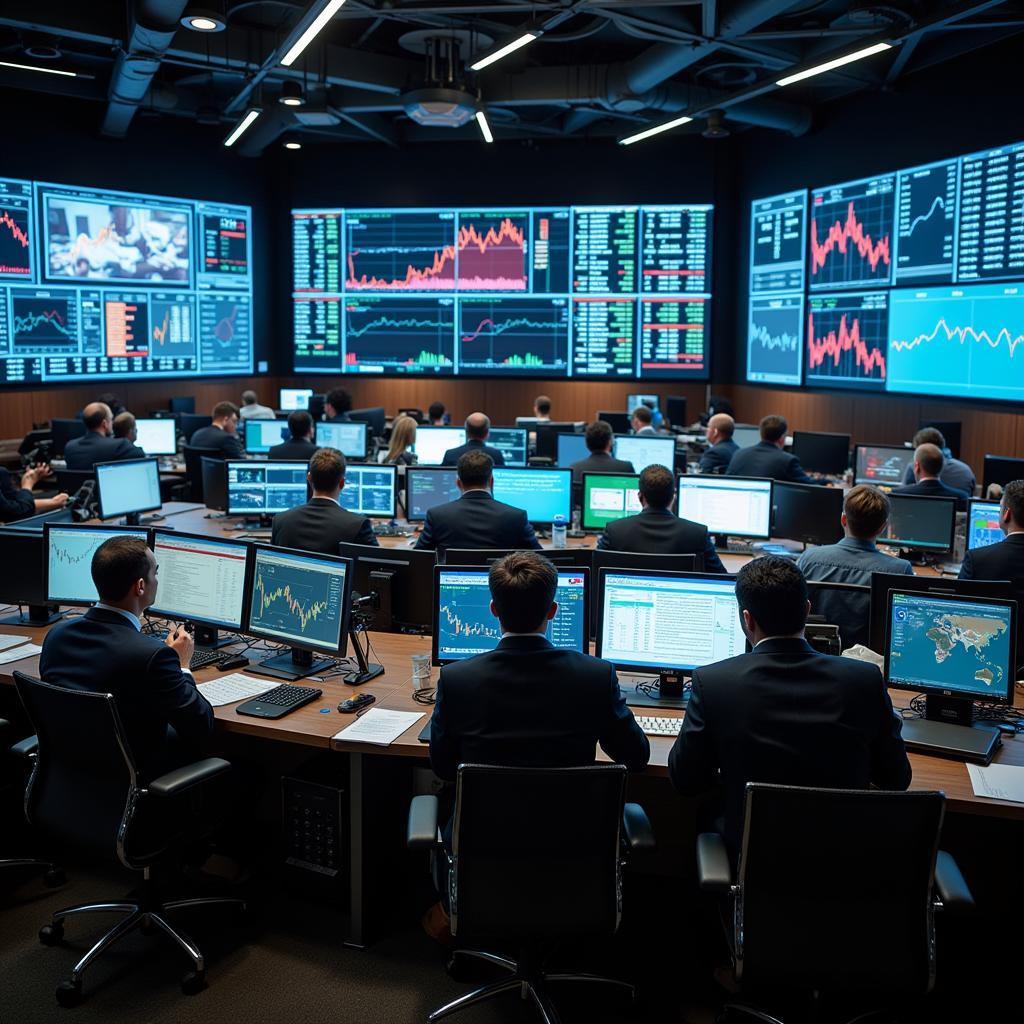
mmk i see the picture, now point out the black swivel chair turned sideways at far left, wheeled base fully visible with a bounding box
[14,671,245,1007]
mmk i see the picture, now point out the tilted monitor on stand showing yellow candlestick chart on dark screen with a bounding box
[244,544,352,679]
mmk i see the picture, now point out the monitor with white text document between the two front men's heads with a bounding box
[595,568,746,673]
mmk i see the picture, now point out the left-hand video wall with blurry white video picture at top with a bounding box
[0,178,253,384]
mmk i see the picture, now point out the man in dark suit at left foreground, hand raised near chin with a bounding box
[39,537,213,777]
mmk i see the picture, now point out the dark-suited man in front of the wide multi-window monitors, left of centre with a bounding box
[270,446,377,555]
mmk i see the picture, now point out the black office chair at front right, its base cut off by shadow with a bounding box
[696,782,974,1024]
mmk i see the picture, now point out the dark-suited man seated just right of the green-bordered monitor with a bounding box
[597,464,726,572]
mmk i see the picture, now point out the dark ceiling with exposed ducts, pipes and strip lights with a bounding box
[0,0,1024,156]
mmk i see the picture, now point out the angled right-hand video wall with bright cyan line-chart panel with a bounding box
[746,143,1024,401]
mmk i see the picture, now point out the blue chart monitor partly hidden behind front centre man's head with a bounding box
[432,565,590,665]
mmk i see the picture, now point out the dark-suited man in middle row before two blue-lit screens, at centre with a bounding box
[416,452,541,551]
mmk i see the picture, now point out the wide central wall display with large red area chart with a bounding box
[292,205,712,380]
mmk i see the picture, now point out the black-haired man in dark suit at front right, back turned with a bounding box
[669,556,910,860]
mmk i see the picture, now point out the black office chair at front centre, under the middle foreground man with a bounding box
[408,765,654,1024]
